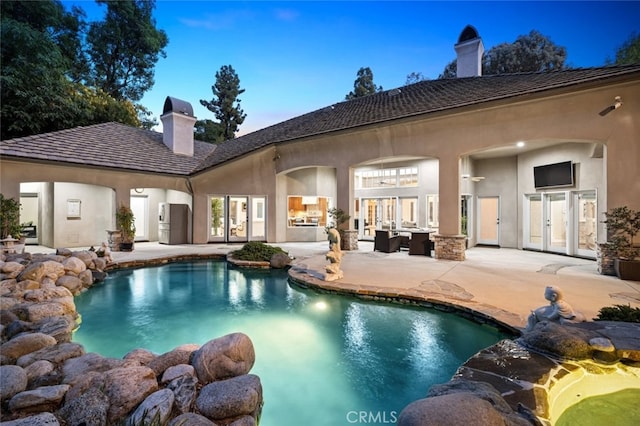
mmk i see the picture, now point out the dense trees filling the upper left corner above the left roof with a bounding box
[0,0,161,139]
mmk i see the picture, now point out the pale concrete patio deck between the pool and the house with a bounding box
[27,241,640,329]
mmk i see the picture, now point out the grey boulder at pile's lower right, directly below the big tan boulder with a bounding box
[196,374,262,421]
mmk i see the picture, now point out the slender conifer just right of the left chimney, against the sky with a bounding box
[200,65,247,142]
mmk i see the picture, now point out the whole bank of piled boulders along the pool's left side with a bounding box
[0,250,263,426]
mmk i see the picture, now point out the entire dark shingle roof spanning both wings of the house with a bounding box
[0,64,640,176]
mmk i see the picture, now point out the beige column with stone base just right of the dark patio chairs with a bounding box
[433,155,466,261]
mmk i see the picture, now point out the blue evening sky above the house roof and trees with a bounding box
[63,0,640,134]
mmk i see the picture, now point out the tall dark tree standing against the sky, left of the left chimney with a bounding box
[87,0,169,102]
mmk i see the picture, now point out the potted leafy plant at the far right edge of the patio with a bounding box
[603,206,640,281]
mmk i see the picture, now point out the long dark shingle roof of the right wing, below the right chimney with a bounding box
[198,64,640,171]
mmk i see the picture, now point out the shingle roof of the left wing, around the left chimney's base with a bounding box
[0,123,215,175]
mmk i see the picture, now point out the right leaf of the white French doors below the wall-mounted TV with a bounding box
[542,192,568,254]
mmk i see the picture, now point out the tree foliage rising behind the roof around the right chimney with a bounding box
[438,30,567,78]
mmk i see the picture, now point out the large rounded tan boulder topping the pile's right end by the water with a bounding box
[191,333,256,384]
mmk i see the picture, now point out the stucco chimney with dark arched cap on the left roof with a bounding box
[160,96,196,157]
